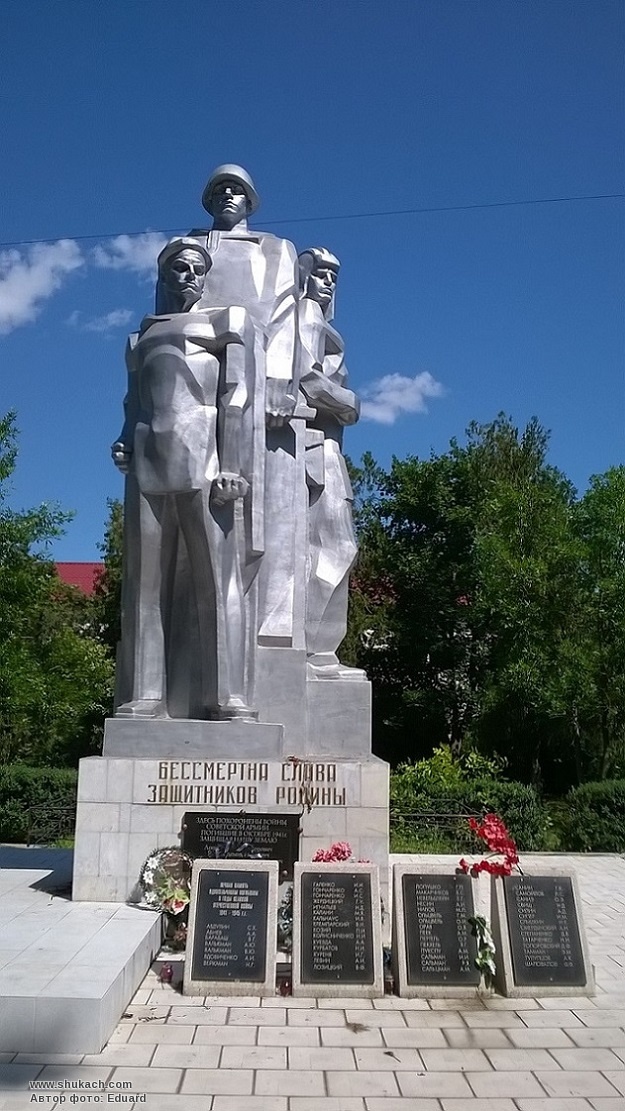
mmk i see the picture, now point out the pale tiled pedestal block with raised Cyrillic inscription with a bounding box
[73,737,389,924]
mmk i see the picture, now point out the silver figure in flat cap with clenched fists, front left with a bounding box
[112,238,264,720]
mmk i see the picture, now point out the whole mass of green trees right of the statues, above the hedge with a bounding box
[349,414,625,791]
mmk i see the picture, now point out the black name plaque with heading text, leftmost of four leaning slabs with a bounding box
[191,867,269,982]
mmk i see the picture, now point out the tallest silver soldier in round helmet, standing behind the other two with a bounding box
[182,164,299,644]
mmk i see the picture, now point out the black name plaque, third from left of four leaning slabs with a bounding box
[402,872,480,987]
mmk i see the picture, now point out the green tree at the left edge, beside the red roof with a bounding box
[0,413,112,764]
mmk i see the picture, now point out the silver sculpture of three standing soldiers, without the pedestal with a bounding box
[112,166,364,721]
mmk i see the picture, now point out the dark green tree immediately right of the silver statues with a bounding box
[346,431,484,761]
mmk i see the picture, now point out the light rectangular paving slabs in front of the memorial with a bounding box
[0,855,625,1111]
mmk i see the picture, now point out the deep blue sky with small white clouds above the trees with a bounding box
[0,0,625,560]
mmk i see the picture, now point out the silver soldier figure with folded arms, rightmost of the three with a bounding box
[299,248,364,679]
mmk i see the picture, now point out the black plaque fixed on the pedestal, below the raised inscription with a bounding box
[181,810,300,882]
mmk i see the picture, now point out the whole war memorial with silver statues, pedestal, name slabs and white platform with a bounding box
[0,166,595,1055]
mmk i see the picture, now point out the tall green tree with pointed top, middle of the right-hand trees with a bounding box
[475,422,586,790]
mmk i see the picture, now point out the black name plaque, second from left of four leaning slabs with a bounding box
[301,870,374,984]
